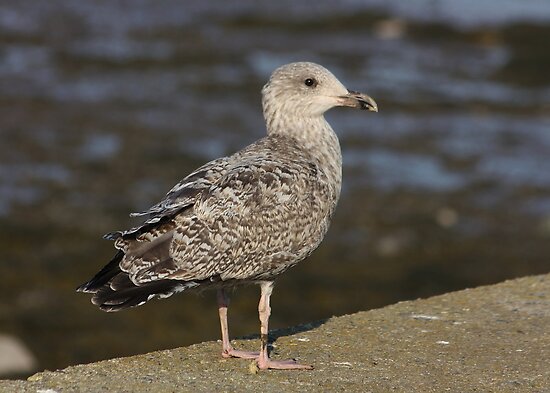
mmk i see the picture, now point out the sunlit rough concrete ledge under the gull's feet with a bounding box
[0,275,550,393]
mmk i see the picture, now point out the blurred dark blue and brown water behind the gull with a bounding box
[0,0,550,375]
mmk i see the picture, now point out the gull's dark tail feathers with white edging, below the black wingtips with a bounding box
[92,273,199,312]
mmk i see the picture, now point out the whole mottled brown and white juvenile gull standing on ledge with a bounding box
[78,62,378,369]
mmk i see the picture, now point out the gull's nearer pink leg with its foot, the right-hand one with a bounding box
[256,282,313,370]
